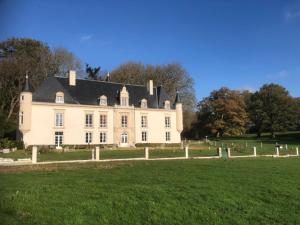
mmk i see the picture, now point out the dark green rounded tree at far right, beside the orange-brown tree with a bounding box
[249,84,296,137]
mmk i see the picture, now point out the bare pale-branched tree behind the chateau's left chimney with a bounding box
[52,48,82,77]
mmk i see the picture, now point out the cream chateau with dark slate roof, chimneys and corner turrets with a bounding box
[19,71,183,148]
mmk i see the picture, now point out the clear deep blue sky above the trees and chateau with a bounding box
[0,0,300,100]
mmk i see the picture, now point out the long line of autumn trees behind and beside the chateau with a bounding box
[0,38,300,138]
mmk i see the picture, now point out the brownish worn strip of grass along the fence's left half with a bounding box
[0,162,133,174]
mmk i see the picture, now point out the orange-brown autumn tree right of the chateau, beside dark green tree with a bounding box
[196,87,248,137]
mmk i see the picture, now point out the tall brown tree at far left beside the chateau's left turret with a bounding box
[0,38,53,134]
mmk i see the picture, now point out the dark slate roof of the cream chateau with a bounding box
[32,77,170,108]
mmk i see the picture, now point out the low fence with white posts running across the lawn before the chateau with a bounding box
[0,146,299,165]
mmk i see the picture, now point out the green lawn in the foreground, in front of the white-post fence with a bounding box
[0,158,300,225]
